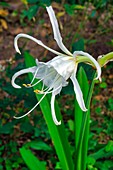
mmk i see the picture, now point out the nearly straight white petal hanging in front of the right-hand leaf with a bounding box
[70,71,87,112]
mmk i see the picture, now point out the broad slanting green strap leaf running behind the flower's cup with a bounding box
[24,52,74,170]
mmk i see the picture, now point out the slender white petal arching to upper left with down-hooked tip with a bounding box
[14,33,65,56]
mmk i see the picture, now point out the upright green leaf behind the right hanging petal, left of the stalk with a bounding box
[75,67,89,170]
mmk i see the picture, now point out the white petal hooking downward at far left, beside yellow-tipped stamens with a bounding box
[11,66,36,88]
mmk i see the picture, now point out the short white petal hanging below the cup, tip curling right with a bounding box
[51,94,61,125]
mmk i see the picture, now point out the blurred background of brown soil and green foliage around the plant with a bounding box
[0,0,113,170]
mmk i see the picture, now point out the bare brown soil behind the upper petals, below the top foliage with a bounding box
[0,1,113,60]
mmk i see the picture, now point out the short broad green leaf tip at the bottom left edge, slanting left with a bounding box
[20,147,46,170]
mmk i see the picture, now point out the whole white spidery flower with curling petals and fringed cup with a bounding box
[12,6,101,125]
